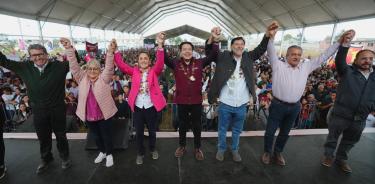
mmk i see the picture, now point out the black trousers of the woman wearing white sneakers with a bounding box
[87,118,113,155]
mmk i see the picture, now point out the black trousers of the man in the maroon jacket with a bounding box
[177,104,202,148]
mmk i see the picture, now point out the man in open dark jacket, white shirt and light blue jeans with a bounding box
[206,22,278,162]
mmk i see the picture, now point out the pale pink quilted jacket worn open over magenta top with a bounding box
[68,48,117,121]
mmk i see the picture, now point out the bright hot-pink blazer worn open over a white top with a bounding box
[115,49,167,112]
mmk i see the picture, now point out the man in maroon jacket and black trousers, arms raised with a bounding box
[164,27,221,160]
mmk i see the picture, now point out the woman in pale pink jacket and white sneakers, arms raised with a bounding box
[60,38,117,167]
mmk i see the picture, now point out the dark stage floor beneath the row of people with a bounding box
[0,133,375,184]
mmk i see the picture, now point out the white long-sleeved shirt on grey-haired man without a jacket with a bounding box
[267,40,340,103]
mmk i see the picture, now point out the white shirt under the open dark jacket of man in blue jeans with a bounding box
[219,57,250,107]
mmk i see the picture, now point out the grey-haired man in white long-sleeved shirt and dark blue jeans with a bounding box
[262,27,356,166]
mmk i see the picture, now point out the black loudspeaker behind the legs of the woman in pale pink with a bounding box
[85,118,129,150]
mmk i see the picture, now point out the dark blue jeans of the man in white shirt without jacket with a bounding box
[264,99,301,153]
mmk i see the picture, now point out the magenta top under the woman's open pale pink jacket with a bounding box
[86,85,104,121]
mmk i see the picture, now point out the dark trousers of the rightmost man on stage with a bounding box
[324,114,366,160]
